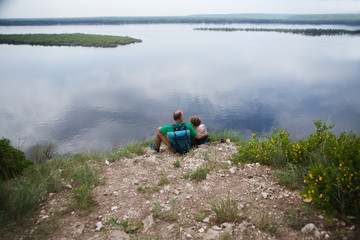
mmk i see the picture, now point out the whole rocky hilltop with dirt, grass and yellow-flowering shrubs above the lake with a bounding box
[0,121,360,239]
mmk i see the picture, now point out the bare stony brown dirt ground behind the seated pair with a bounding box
[29,143,358,240]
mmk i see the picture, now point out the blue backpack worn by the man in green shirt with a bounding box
[168,123,191,154]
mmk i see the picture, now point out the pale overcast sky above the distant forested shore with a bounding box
[0,0,360,18]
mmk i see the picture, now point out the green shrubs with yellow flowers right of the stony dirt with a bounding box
[230,120,360,217]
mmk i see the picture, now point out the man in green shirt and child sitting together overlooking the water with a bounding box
[150,110,208,153]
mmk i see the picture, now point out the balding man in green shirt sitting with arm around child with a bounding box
[150,110,208,153]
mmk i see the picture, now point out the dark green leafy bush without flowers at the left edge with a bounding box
[0,138,33,180]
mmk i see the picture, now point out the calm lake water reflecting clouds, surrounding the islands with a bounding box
[0,24,360,153]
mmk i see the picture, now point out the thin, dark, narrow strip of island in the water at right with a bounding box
[194,27,360,36]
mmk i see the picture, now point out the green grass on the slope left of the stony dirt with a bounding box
[0,141,152,236]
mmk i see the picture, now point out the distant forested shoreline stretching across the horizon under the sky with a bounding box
[0,14,360,26]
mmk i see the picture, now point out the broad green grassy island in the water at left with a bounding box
[0,33,142,48]
